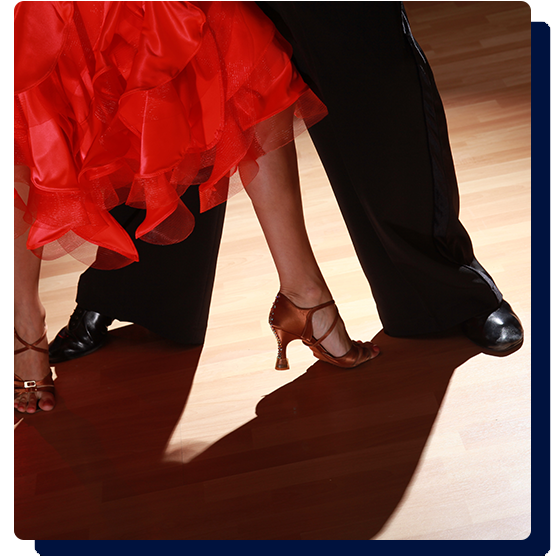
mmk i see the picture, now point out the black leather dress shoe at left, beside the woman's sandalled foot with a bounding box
[49,305,113,364]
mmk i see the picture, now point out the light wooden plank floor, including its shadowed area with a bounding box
[14,2,531,540]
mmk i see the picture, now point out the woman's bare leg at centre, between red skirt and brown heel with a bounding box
[246,138,372,356]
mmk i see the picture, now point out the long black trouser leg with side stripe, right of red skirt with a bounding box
[257,0,502,336]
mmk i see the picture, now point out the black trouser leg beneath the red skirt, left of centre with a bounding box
[76,186,226,345]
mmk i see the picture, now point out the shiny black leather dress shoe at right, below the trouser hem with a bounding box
[462,301,523,352]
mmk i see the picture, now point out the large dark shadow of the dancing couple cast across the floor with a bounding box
[14,327,479,540]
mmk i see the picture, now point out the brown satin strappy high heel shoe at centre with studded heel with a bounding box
[268,293,379,370]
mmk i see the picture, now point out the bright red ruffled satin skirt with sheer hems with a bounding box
[14,1,326,268]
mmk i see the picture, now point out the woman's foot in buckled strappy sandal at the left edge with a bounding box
[14,324,56,414]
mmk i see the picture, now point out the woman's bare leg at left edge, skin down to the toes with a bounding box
[14,230,55,413]
